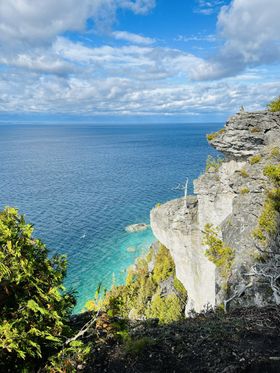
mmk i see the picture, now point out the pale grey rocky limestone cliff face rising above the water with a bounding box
[151,112,280,314]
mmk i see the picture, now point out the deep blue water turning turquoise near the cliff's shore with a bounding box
[0,124,221,311]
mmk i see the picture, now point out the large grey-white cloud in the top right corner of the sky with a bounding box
[193,0,280,80]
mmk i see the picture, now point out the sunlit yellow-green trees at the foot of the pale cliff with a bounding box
[86,245,187,323]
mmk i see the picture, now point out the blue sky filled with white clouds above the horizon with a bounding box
[0,0,280,123]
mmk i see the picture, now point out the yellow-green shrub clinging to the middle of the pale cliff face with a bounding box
[203,224,234,279]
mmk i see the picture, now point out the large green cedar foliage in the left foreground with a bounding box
[0,207,74,369]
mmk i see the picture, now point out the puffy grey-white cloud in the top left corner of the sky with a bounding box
[0,0,155,43]
